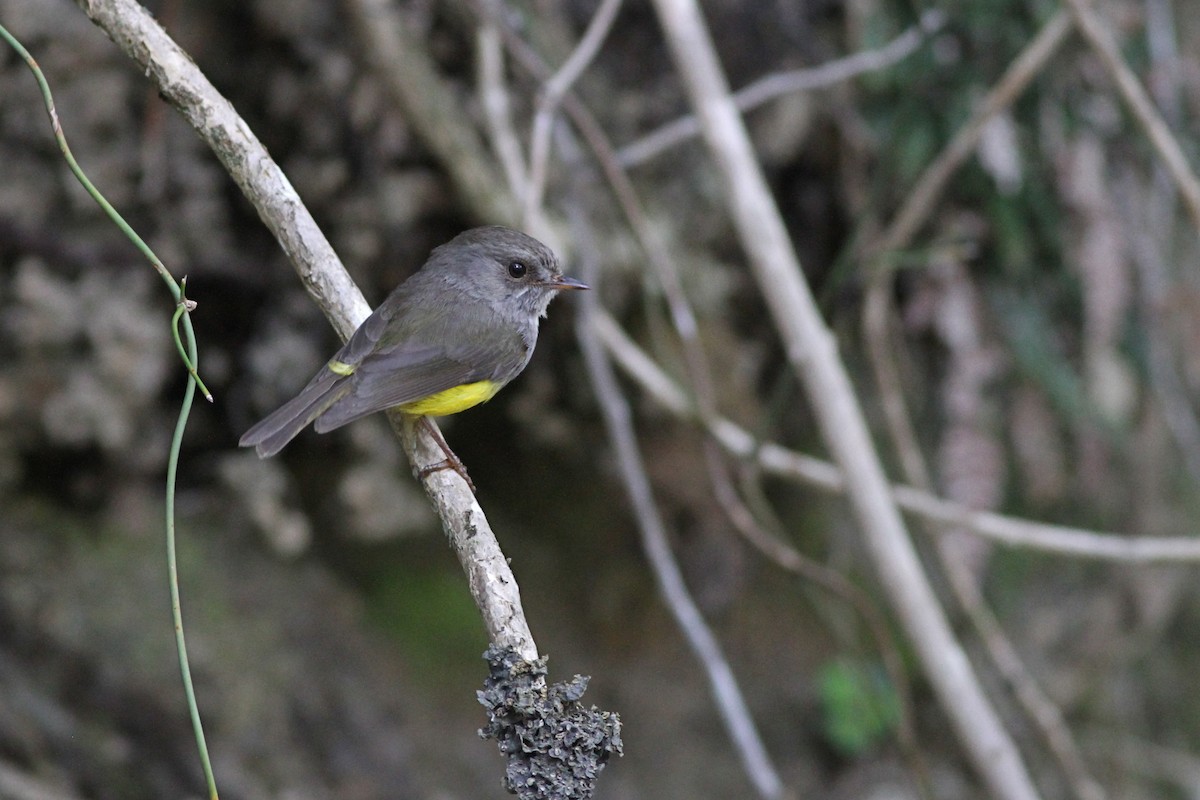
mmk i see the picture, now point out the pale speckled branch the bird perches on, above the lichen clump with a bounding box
[78,0,538,661]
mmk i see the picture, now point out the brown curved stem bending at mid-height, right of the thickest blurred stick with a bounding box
[863,11,1104,800]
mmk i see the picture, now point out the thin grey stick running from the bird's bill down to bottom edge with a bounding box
[571,209,784,799]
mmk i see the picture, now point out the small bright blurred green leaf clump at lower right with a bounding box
[817,658,900,756]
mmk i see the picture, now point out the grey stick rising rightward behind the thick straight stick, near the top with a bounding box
[617,8,947,169]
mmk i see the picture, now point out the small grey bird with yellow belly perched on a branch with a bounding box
[238,225,588,491]
